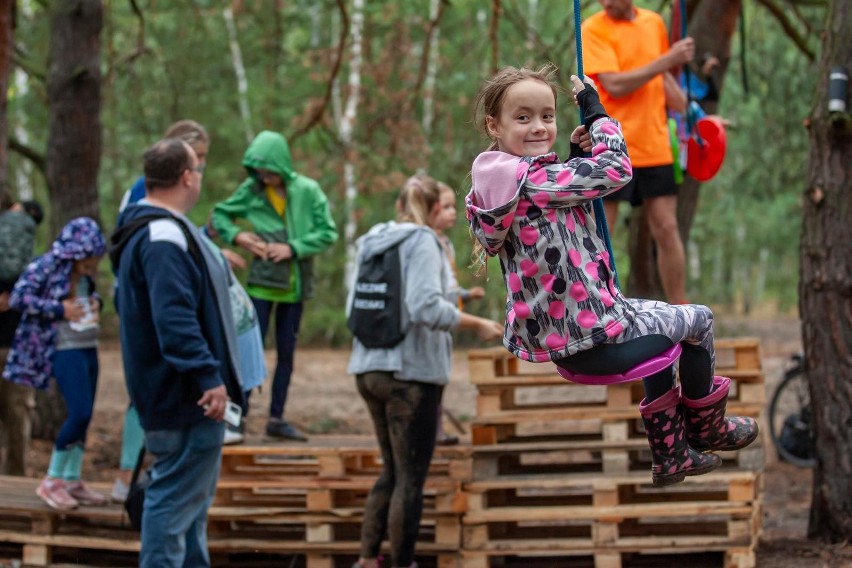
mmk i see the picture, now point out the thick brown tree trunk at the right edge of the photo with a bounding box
[799,0,852,542]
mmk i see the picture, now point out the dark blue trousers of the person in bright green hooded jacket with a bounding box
[251,298,303,418]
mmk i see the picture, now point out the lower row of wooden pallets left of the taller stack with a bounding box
[0,436,470,568]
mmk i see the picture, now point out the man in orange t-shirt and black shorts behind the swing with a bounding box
[583,0,695,304]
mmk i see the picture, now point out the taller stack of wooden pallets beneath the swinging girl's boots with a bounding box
[462,339,765,568]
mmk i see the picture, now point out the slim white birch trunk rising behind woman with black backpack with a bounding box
[338,0,364,288]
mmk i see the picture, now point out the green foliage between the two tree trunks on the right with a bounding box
[690,3,823,311]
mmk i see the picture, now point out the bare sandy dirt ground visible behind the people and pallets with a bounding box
[16,316,852,568]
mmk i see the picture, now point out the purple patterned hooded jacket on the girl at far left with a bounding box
[3,217,106,389]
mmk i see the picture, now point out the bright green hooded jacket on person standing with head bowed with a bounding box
[213,130,337,303]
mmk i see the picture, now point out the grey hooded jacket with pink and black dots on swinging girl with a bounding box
[466,118,634,362]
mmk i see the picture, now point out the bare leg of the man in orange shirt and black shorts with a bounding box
[642,195,687,304]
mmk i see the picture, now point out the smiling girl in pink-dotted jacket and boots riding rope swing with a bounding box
[467,66,757,485]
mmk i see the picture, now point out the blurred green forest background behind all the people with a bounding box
[7,0,825,345]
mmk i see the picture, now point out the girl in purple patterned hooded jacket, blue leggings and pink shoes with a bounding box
[3,217,107,509]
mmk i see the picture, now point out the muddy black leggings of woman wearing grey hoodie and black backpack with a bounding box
[356,371,442,566]
